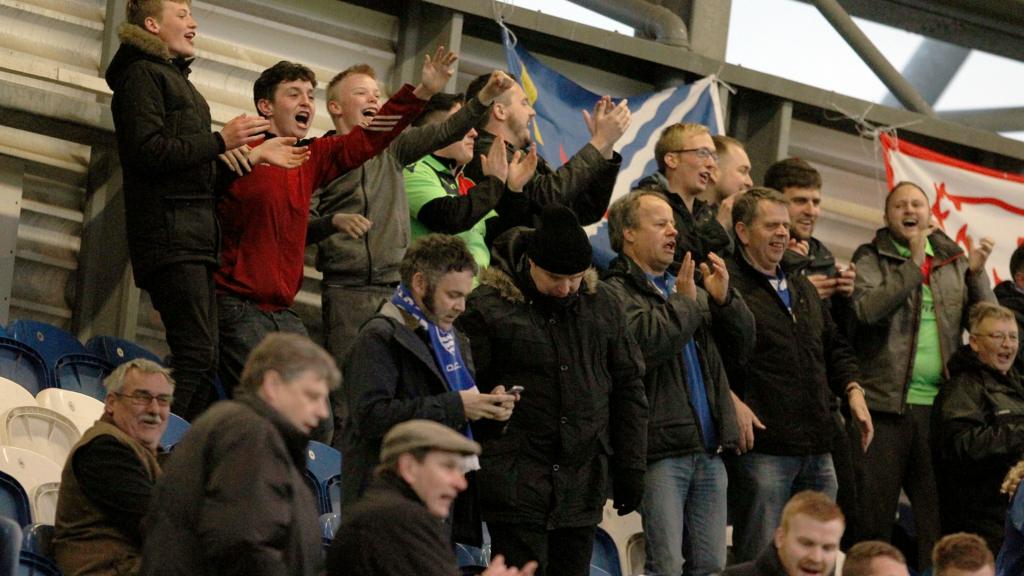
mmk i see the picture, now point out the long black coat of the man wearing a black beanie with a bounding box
[457,228,647,528]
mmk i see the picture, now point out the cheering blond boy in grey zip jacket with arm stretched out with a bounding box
[306,64,513,448]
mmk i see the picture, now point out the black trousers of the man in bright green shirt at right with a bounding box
[851,406,939,570]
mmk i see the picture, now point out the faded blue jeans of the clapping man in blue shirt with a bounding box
[640,453,729,576]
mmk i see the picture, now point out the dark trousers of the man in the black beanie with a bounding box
[487,522,597,576]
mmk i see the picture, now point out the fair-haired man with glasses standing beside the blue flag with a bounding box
[637,124,732,275]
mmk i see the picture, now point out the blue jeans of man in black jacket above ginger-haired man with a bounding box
[728,452,838,563]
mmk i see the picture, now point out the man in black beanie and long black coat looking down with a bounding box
[457,204,647,576]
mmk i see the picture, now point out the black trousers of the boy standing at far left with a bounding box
[144,262,217,421]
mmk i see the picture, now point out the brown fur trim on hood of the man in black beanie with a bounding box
[480,227,598,302]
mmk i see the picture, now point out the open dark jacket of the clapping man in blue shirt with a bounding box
[604,256,755,461]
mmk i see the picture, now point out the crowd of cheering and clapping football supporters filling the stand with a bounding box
[46,0,1024,576]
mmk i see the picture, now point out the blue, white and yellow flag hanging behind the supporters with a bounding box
[502,28,723,266]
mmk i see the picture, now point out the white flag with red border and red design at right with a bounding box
[881,129,1024,286]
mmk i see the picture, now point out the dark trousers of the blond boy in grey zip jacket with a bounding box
[321,283,394,450]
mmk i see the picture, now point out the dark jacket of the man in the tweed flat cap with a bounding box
[327,471,459,576]
